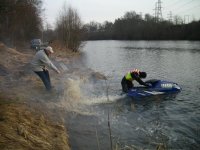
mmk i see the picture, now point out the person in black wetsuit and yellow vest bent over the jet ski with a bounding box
[121,69,150,93]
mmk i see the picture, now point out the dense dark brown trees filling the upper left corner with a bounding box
[0,0,42,46]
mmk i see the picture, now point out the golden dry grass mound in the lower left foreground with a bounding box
[0,97,70,150]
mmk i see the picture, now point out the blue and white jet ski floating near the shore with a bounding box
[127,79,181,98]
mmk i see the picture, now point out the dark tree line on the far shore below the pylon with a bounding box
[83,11,200,40]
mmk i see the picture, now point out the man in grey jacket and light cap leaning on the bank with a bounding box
[31,46,60,91]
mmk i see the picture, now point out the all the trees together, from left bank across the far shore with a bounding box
[0,0,200,51]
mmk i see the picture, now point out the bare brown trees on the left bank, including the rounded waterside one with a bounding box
[0,0,82,51]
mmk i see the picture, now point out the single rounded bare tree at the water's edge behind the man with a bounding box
[56,5,82,52]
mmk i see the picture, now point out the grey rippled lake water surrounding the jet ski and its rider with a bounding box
[66,41,200,150]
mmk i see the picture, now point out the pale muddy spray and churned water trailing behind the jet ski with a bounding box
[49,72,124,114]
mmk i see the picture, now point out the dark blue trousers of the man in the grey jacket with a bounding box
[34,70,52,91]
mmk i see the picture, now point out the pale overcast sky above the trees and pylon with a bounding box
[43,0,200,26]
